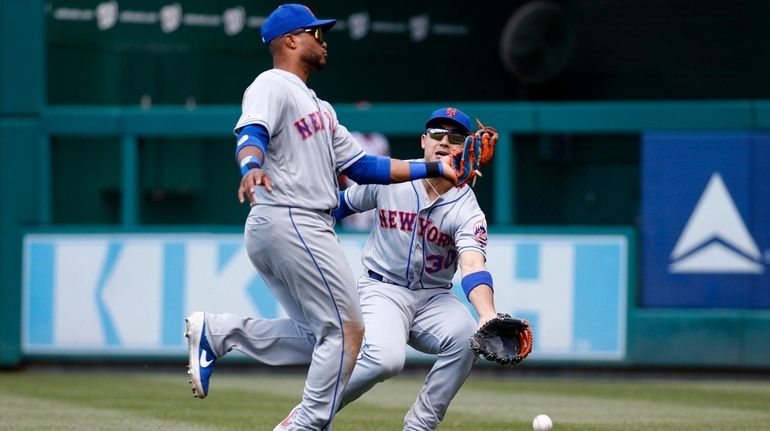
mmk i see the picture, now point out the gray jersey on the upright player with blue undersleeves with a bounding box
[235,69,366,210]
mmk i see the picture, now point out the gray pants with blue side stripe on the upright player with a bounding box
[206,205,363,431]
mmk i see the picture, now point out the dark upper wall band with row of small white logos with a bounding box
[43,0,770,106]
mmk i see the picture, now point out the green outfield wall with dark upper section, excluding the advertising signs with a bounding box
[0,0,770,369]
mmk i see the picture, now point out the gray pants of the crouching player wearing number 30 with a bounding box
[342,276,477,431]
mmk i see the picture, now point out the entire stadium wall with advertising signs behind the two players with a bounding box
[0,0,770,373]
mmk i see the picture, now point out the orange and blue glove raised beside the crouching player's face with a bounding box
[451,119,498,187]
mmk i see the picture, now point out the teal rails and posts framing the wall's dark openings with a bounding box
[0,101,770,369]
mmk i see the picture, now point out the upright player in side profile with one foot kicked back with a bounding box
[180,4,456,430]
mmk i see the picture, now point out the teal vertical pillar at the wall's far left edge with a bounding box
[0,0,47,365]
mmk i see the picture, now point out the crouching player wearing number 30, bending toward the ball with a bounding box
[334,107,496,431]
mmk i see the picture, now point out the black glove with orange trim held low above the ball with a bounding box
[471,313,532,365]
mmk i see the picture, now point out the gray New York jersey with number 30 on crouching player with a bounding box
[345,164,487,290]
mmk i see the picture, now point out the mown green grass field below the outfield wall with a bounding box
[0,368,770,431]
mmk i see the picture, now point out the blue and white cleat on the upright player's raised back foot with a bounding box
[184,311,217,399]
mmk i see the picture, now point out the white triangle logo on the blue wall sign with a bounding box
[668,172,765,274]
